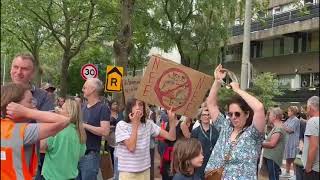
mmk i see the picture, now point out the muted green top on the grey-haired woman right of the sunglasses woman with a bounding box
[263,127,287,167]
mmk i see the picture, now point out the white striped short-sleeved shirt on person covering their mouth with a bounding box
[116,120,160,172]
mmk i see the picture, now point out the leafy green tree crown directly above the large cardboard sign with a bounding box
[152,0,237,74]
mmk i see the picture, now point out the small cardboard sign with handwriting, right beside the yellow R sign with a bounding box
[122,76,142,100]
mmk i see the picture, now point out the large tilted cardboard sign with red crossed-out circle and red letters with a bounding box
[136,56,213,117]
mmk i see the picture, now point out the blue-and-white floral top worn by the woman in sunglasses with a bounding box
[206,113,263,180]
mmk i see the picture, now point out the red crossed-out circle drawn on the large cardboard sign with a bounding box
[154,68,192,111]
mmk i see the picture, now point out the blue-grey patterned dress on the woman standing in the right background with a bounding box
[283,116,300,159]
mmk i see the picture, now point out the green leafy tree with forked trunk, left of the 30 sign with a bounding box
[21,0,106,96]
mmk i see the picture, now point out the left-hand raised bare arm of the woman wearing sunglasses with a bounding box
[207,64,226,122]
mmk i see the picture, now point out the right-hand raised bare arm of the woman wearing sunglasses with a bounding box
[230,82,266,133]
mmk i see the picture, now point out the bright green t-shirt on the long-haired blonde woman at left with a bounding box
[41,124,86,180]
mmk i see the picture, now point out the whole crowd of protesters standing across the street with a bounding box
[1,54,319,180]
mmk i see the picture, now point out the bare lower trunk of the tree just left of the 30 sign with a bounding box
[60,52,70,97]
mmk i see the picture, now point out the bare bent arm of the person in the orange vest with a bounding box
[7,102,70,140]
